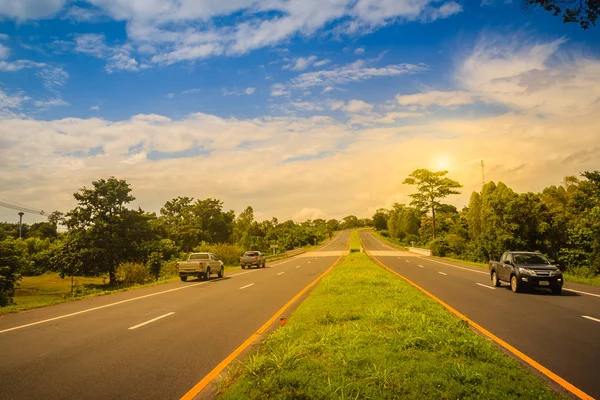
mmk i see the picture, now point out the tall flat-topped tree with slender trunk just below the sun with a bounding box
[402,169,462,239]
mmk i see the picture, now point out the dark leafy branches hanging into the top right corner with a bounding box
[524,0,600,29]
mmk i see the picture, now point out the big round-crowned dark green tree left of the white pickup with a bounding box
[65,177,152,284]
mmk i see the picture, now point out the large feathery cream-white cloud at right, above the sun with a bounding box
[457,35,600,114]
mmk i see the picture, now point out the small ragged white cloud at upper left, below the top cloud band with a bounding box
[75,33,140,74]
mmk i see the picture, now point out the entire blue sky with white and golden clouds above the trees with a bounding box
[0,0,600,219]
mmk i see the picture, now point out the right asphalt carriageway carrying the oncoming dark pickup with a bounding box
[360,231,600,399]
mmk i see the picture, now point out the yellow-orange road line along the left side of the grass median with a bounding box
[181,243,350,400]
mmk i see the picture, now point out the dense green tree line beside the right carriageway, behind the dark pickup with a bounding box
[373,170,600,276]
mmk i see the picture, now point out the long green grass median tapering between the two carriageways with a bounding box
[217,248,560,400]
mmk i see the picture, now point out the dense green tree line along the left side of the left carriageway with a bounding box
[0,177,372,306]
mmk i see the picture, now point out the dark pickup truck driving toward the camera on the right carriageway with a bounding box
[488,251,564,295]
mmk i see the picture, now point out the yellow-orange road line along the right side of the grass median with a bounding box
[359,235,594,400]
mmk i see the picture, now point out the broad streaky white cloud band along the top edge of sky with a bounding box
[11,0,462,70]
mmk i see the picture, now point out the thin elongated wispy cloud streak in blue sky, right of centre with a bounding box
[290,60,427,89]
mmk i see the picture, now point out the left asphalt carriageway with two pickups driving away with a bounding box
[0,232,349,400]
